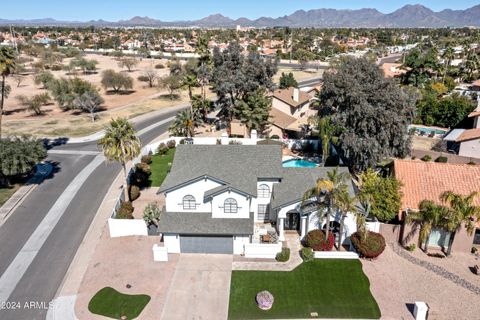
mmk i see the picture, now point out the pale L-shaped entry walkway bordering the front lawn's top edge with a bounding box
[232,233,303,271]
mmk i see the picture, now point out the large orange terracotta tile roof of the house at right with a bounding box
[394,160,480,210]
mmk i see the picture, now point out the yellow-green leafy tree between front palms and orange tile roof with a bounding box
[358,169,401,222]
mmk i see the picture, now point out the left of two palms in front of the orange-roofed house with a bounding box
[407,200,449,252]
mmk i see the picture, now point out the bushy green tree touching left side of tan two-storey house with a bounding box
[233,89,272,134]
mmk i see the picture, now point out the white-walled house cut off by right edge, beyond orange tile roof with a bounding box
[443,103,480,158]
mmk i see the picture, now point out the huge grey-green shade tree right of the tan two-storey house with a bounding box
[319,58,415,172]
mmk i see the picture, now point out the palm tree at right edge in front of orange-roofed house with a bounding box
[440,191,480,256]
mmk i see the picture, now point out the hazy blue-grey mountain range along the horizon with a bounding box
[0,4,480,28]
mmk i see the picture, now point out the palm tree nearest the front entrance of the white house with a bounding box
[302,168,348,239]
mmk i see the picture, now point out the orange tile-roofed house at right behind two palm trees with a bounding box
[394,160,480,254]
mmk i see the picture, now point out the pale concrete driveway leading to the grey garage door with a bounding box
[162,254,233,320]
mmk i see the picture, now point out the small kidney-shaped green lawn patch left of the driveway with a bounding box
[88,287,150,319]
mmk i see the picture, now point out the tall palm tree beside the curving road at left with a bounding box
[98,118,141,199]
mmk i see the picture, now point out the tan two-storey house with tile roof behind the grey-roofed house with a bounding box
[269,88,316,138]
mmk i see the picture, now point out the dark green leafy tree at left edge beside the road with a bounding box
[0,136,47,186]
